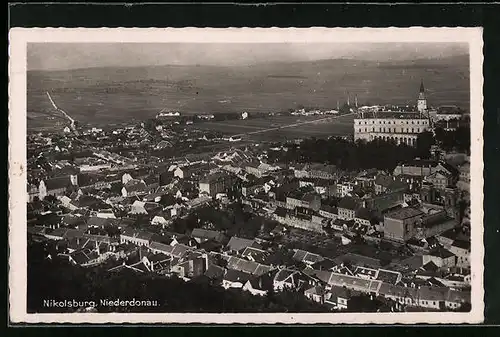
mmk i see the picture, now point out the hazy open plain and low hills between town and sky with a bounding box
[27,55,469,129]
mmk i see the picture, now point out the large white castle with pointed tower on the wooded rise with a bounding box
[354,83,430,146]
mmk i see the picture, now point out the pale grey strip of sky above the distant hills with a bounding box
[27,43,468,70]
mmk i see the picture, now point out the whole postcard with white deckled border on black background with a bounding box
[9,28,483,323]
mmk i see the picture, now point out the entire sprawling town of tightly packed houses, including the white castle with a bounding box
[27,83,474,312]
